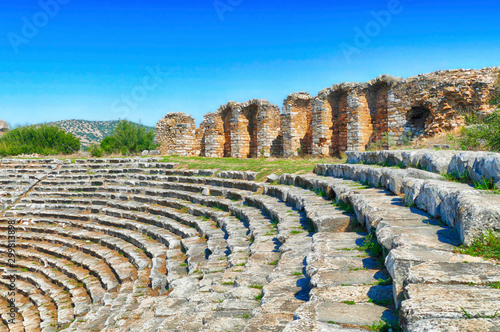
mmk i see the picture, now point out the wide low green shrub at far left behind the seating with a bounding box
[0,125,80,156]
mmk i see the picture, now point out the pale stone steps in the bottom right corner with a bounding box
[401,262,500,331]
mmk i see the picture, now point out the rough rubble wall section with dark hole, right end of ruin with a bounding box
[391,67,500,141]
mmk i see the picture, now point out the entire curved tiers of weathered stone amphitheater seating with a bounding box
[0,158,500,331]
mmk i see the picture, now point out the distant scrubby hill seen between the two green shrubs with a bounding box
[42,120,155,148]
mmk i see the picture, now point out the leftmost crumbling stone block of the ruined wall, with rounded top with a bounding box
[156,113,200,156]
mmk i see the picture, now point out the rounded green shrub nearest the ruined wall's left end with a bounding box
[101,120,158,155]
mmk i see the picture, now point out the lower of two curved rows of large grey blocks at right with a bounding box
[315,160,500,245]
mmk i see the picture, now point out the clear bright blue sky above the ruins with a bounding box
[0,0,500,125]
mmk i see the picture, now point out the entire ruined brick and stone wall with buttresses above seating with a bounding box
[158,67,500,158]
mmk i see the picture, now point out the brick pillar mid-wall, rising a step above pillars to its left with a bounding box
[281,92,313,157]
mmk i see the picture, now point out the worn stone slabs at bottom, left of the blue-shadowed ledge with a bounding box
[287,228,397,331]
